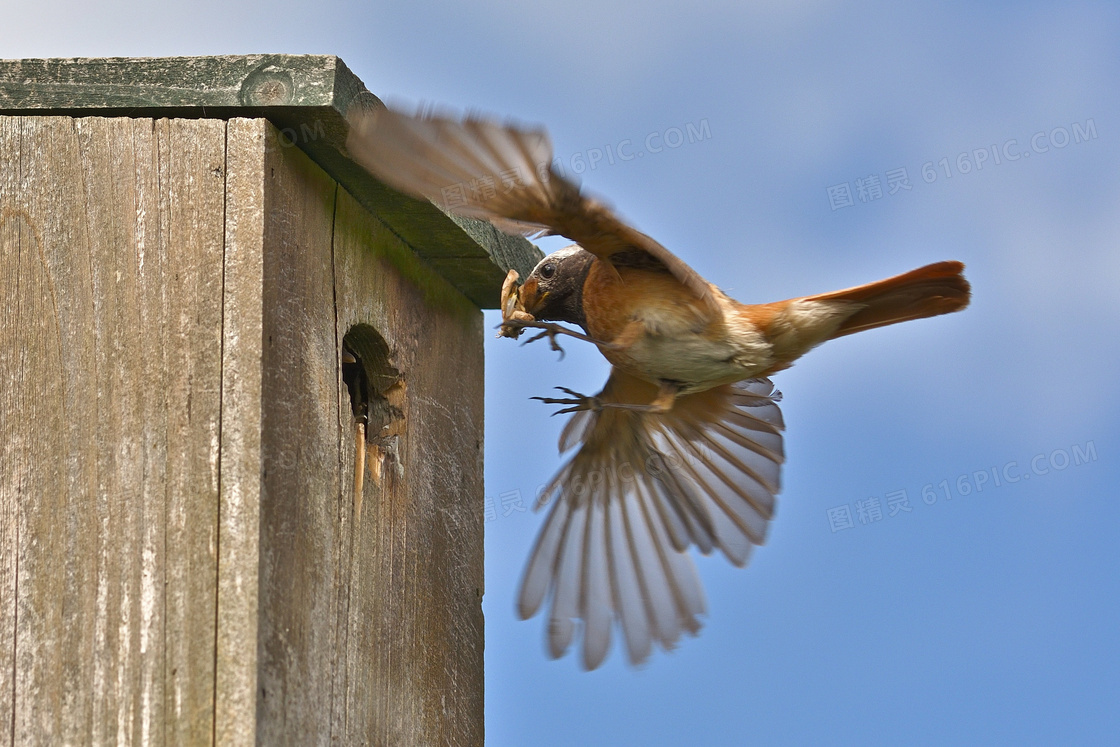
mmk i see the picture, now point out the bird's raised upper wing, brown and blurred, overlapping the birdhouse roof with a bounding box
[346,106,716,305]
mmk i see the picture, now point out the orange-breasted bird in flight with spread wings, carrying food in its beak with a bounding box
[346,102,971,670]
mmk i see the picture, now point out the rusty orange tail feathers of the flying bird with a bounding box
[810,262,970,338]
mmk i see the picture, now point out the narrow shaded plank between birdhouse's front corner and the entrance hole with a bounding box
[256,121,349,745]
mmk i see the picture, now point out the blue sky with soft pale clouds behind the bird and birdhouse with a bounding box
[10,0,1120,745]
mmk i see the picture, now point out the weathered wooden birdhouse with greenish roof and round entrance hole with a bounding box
[0,55,540,745]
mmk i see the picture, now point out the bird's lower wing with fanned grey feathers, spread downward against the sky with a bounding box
[517,368,784,670]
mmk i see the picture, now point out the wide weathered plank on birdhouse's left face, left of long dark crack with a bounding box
[0,118,225,744]
